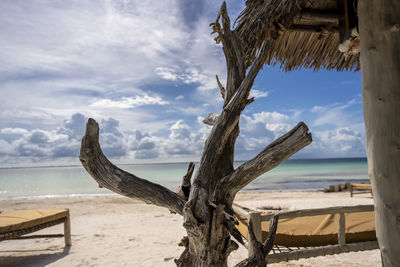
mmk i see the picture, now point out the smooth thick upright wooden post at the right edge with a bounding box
[358,0,400,267]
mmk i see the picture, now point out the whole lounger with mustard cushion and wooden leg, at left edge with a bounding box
[0,209,71,246]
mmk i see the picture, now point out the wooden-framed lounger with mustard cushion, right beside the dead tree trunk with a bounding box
[233,204,378,263]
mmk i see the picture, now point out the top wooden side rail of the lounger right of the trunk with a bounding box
[261,205,374,221]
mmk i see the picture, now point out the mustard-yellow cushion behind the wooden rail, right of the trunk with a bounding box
[237,212,376,247]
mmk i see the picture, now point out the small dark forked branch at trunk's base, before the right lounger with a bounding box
[235,215,279,267]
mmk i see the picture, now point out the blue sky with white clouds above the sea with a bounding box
[0,0,365,166]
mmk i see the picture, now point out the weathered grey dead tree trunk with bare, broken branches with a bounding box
[80,3,312,267]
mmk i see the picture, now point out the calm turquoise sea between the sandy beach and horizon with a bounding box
[0,158,369,199]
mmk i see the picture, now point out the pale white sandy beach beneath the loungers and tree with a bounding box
[0,191,380,267]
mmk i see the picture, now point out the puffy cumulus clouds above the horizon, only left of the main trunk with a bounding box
[0,113,210,164]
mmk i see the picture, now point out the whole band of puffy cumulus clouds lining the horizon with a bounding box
[0,108,365,164]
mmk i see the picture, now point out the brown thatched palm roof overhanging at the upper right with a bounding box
[236,0,360,71]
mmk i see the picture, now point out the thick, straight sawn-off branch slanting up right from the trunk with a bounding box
[221,122,312,194]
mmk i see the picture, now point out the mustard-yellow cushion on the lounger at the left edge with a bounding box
[0,210,69,233]
